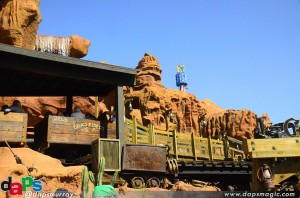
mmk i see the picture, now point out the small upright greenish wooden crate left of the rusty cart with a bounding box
[91,138,121,172]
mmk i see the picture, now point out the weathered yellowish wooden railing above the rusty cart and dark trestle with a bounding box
[124,118,244,161]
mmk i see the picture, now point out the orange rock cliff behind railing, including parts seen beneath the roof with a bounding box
[0,53,271,140]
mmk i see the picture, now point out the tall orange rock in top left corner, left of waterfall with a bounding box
[0,0,42,49]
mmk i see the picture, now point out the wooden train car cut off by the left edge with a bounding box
[0,112,28,144]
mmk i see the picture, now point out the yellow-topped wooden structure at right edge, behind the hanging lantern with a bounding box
[244,137,300,191]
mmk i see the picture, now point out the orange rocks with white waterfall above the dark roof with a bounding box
[0,0,91,58]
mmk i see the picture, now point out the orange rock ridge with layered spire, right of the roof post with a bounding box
[124,53,267,139]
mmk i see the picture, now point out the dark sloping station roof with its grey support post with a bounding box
[0,44,138,150]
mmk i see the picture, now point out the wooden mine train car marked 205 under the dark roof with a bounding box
[34,115,100,162]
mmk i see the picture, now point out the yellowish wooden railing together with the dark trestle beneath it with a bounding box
[124,117,252,185]
